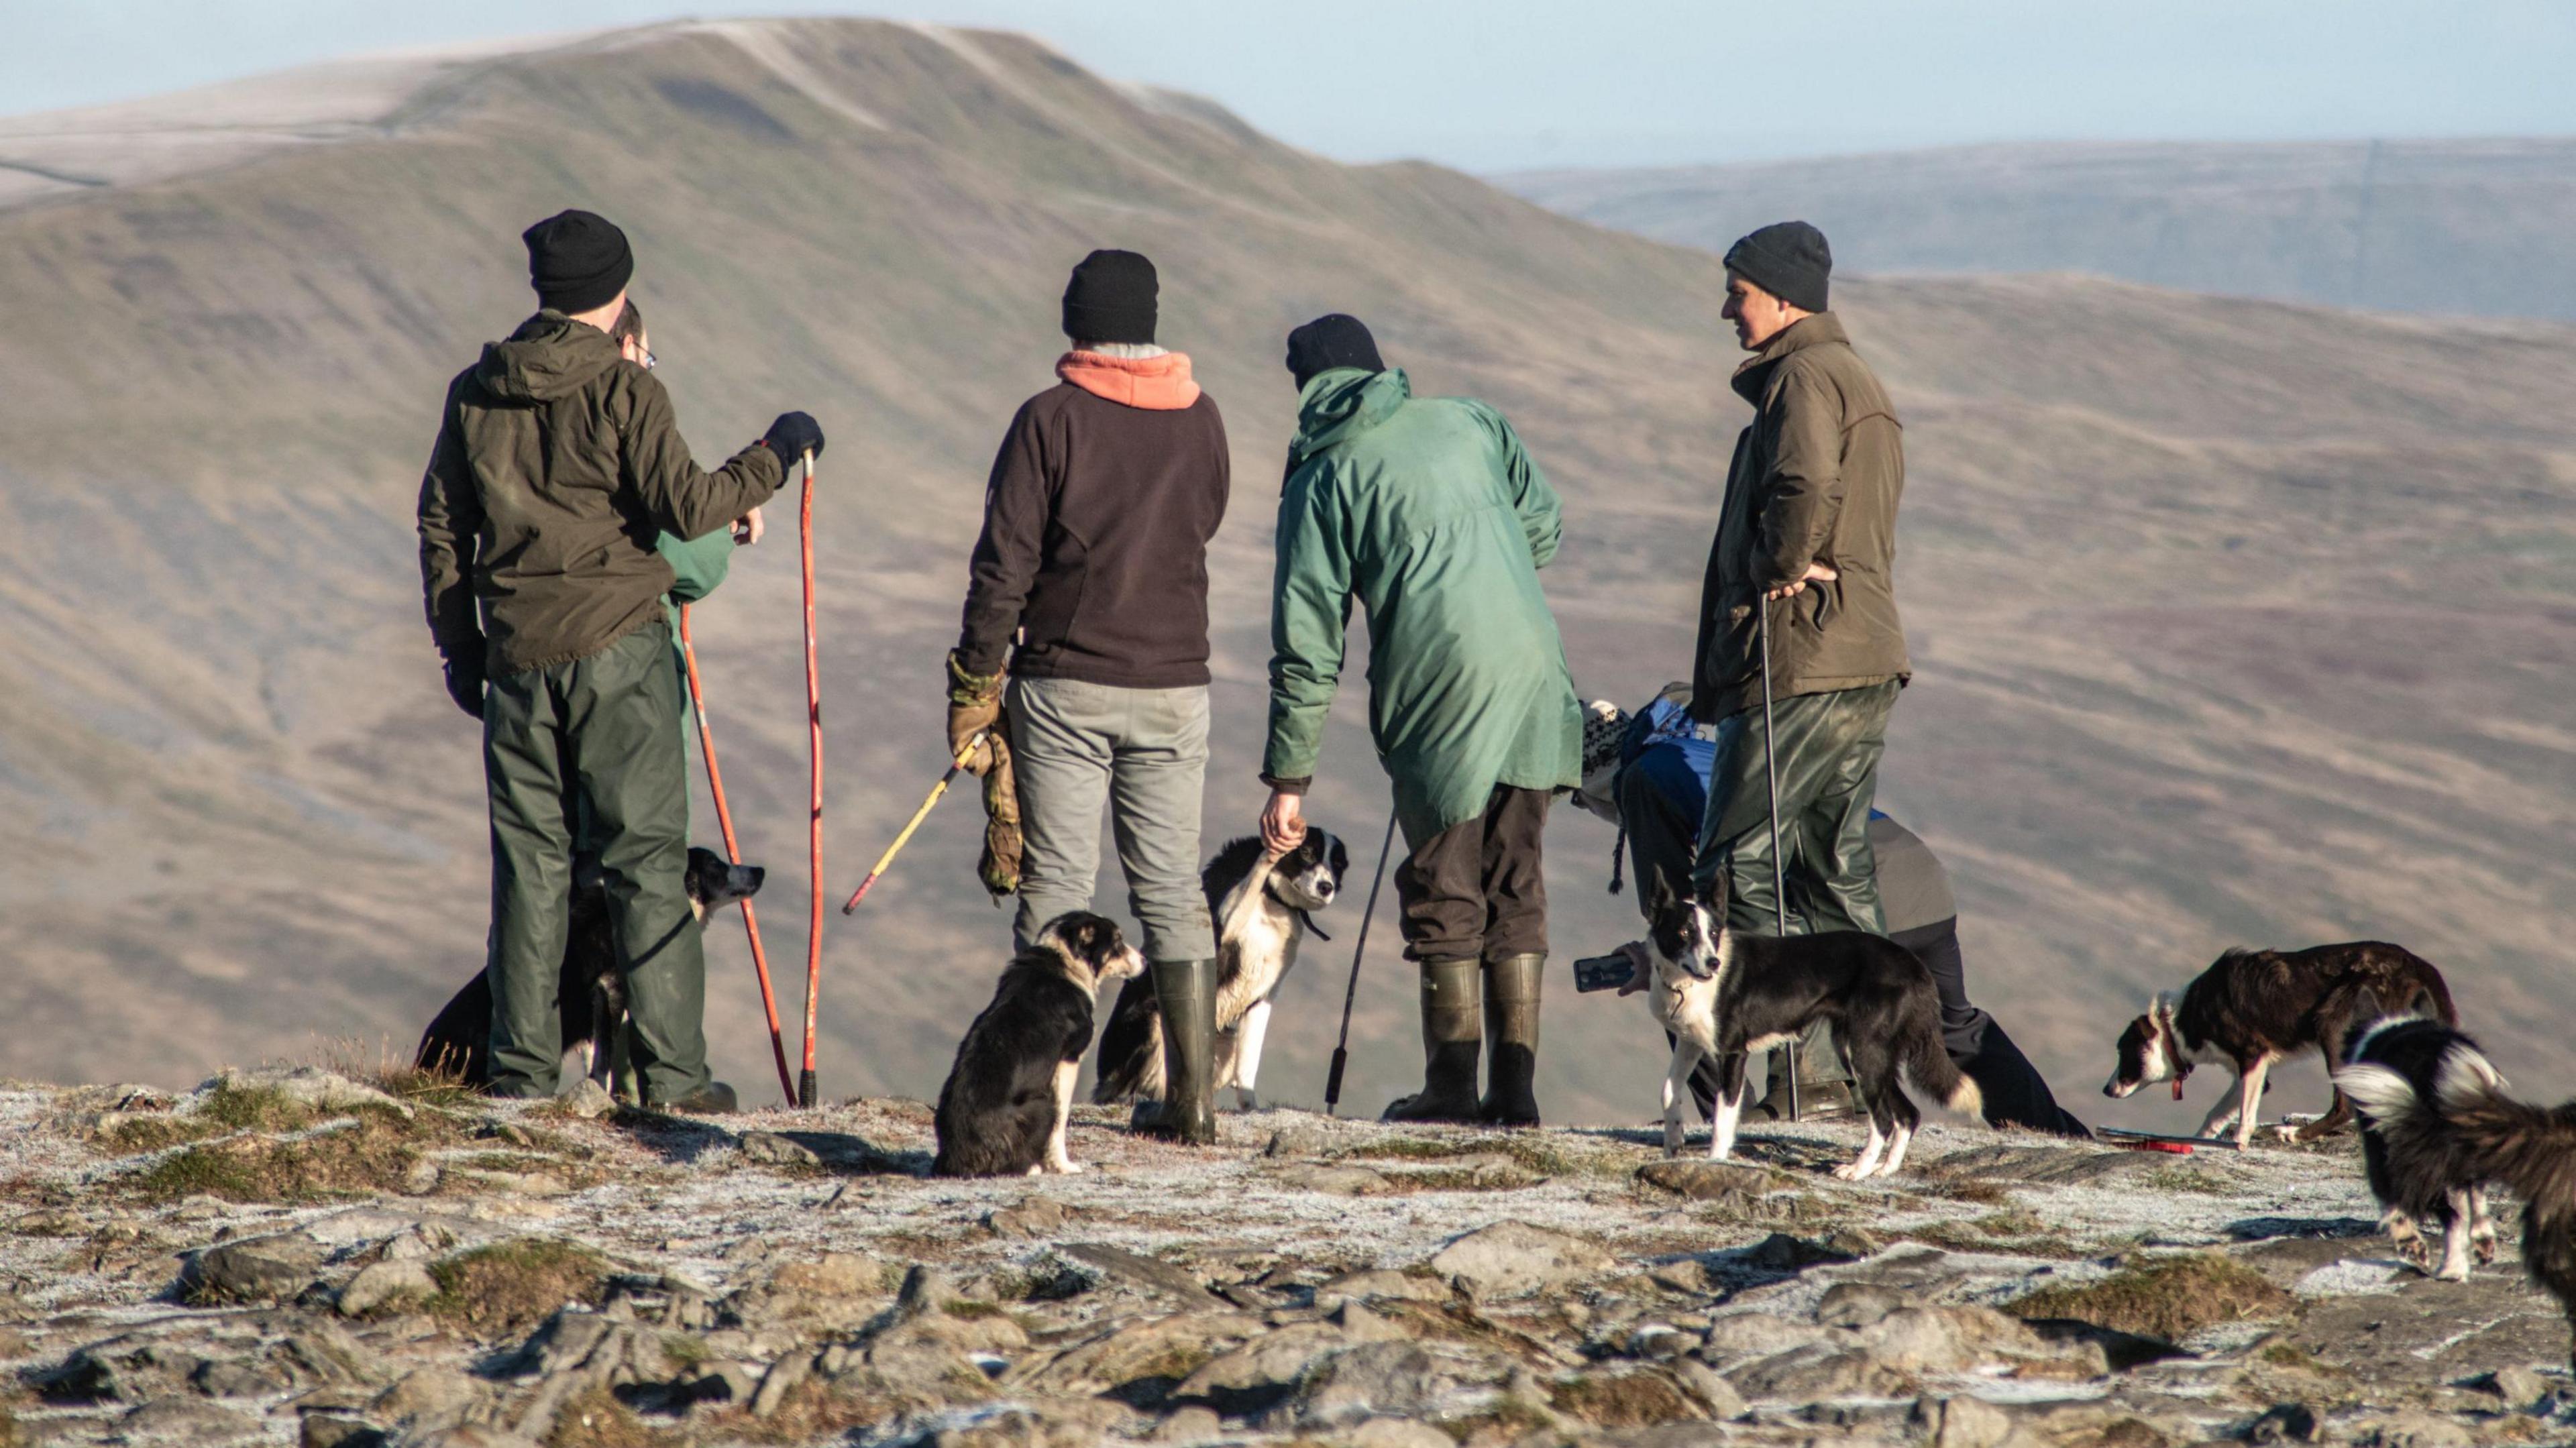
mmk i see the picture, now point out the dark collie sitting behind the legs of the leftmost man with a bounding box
[412,848,767,1100]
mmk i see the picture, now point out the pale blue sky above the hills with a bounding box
[0,0,2576,170]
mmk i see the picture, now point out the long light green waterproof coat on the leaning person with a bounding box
[1263,368,1585,848]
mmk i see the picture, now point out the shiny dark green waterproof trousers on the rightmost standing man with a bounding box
[1693,680,1898,1082]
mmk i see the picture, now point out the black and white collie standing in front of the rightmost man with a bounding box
[1646,871,1984,1180]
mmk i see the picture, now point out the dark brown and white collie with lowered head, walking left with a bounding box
[2102,940,2460,1147]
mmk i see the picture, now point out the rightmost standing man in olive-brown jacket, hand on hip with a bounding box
[1693,221,1914,1107]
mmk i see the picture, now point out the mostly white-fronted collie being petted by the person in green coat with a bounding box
[1092,827,1350,1111]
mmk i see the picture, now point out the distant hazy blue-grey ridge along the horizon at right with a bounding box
[1499,139,2576,319]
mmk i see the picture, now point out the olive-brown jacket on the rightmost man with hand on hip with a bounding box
[1693,312,1914,722]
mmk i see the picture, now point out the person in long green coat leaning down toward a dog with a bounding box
[1263,315,1582,1126]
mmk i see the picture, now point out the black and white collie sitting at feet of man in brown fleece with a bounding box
[930,909,1144,1178]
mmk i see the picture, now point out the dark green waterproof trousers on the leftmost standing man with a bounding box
[484,621,708,1105]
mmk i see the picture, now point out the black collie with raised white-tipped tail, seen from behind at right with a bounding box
[2334,1000,2504,1283]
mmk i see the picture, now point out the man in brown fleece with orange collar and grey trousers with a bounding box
[948,250,1229,1144]
